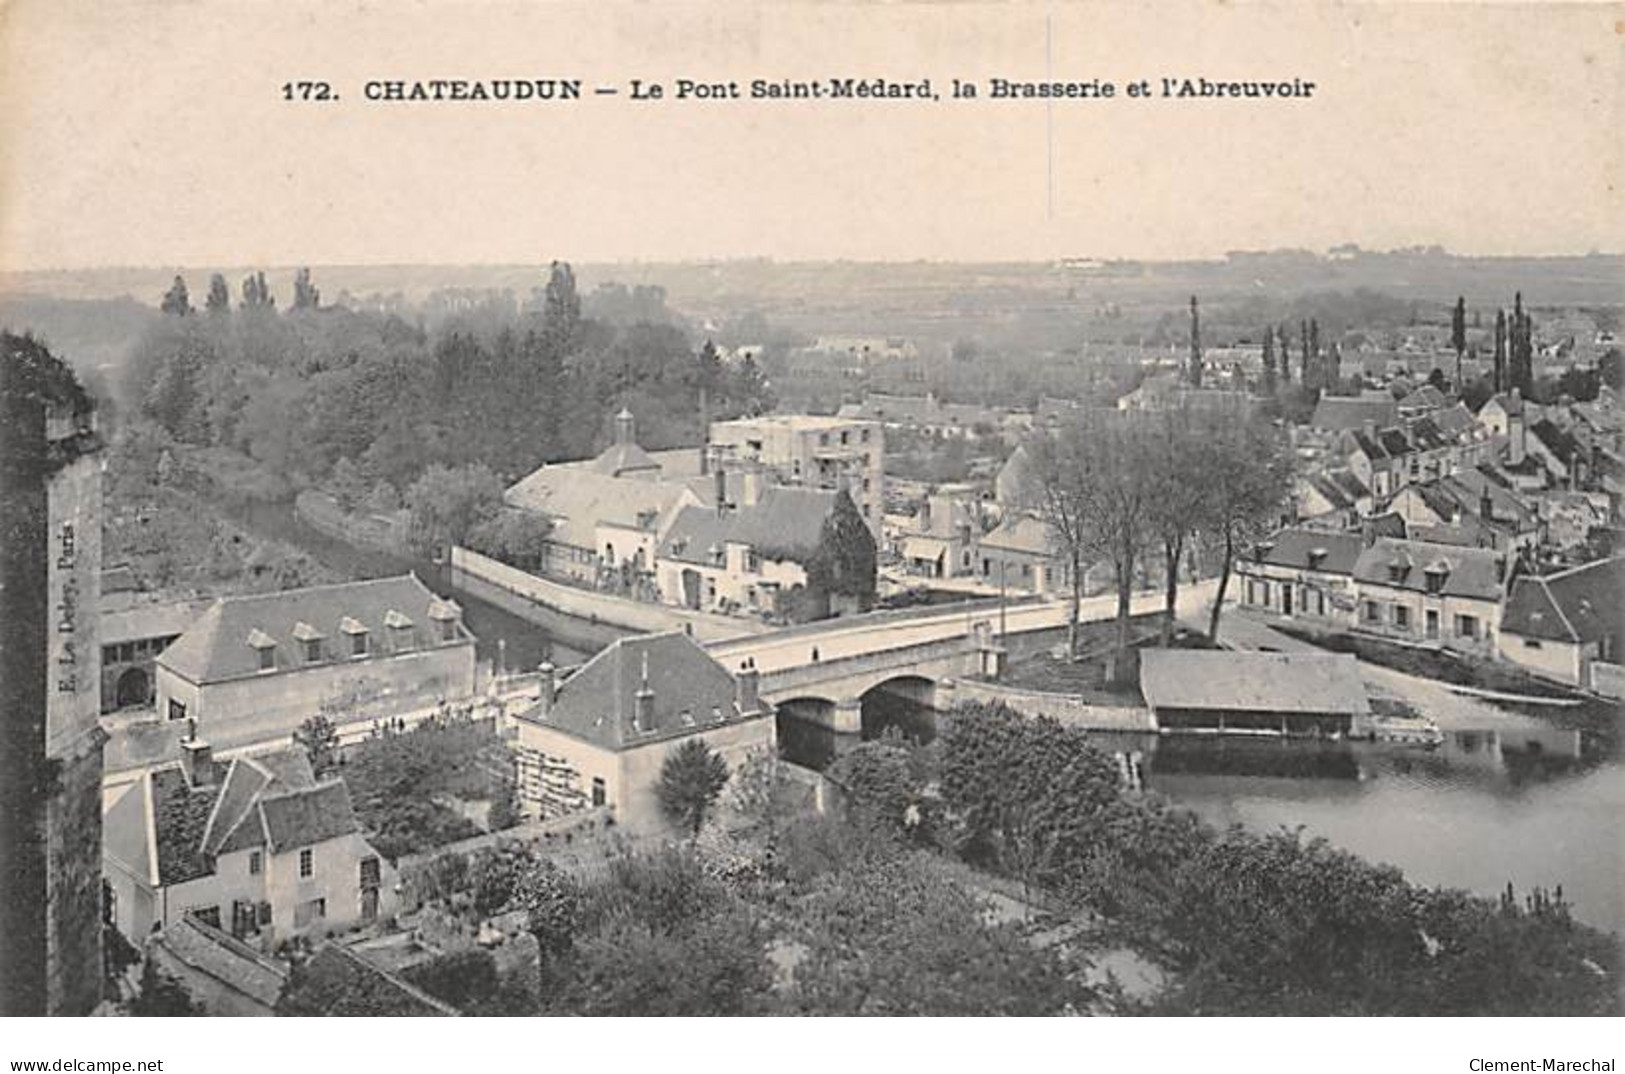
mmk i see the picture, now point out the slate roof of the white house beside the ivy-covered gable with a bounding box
[660,486,835,565]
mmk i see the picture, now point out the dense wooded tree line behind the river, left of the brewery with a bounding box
[122,262,774,499]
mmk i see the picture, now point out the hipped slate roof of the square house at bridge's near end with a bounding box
[522,630,767,749]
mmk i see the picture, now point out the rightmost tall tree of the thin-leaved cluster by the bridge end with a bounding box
[1194,422,1294,639]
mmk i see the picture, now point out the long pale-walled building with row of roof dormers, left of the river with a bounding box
[154,574,475,749]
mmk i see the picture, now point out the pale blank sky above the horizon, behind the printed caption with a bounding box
[0,0,1625,271]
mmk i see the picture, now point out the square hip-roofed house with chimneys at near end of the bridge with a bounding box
[507,632,777,832]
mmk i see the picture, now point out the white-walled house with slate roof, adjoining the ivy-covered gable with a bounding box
[655,486,837,616]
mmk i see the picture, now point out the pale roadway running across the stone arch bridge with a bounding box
[707,582,1214,673]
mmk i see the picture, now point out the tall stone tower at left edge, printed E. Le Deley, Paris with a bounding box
[0,333,106,1016]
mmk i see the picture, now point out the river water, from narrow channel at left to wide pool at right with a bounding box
[232,504,1625,933]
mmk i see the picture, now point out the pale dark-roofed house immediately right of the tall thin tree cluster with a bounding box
[1235,528,1365,627]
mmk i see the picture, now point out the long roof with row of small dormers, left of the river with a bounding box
[158,574,473,682]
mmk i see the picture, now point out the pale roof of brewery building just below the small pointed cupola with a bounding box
[502,465,694,549]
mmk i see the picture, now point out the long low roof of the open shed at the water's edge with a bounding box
[1139,648,1370,715]
